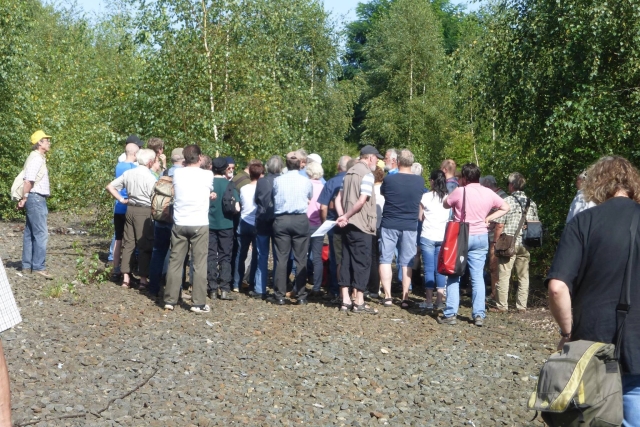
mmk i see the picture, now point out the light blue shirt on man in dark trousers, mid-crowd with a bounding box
[273,170,313,215]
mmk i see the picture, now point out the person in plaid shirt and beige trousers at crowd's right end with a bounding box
[489,172,538,312]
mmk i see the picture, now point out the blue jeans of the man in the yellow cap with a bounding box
[22,193,49,271]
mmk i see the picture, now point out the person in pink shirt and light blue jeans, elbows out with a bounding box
[437,163,509,326]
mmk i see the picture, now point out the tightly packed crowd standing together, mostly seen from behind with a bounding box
[92,135,552,326]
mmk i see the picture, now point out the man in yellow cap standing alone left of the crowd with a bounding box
[18,130,53,279]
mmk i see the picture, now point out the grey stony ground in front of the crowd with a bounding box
[0,216,557,426]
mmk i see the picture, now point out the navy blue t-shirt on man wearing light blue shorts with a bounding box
[380,173,424,231]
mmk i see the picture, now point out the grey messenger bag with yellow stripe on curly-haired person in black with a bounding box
[527,212,640,427]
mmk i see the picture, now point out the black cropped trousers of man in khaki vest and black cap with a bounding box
[340,224,373,292]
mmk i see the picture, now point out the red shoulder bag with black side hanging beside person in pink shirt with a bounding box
[438,188,469,276]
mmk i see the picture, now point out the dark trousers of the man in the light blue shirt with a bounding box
[273,214,309,299]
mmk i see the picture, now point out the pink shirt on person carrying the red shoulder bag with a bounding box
[447,183,504,236]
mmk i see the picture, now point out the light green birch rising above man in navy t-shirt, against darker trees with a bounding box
[363,0,451,170]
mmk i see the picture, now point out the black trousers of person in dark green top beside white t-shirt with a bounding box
[207,228,234,292]
